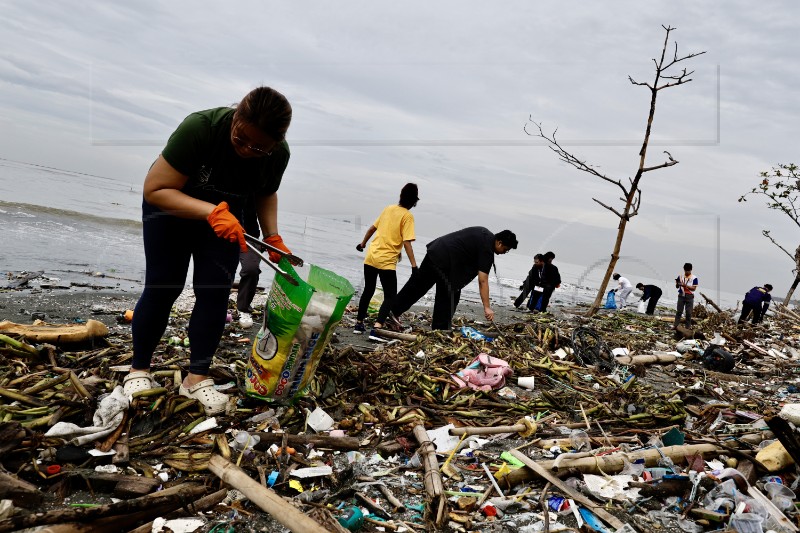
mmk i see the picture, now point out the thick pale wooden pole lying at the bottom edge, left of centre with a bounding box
[208,455,326,533]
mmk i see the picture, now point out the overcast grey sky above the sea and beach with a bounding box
[0,0,800,294]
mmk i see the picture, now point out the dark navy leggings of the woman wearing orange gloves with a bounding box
[131,202,239,375]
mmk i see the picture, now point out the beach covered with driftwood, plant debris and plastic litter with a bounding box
[0,300,800,533]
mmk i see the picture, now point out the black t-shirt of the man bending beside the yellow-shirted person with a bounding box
[428,226,495,289]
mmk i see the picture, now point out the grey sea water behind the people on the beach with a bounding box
[0,159,735,310]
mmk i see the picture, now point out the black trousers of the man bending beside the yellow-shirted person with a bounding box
[392,256,461,329]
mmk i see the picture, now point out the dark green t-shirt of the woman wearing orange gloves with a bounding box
[161,107,289,221]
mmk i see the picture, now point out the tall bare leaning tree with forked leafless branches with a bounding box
[525,26,705,316]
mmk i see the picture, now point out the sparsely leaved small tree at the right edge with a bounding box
[739,163,800,305]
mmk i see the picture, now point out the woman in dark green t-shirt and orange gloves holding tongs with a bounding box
[123,87,292,415]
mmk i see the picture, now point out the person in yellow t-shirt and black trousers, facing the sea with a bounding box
[353,183,419,333]
